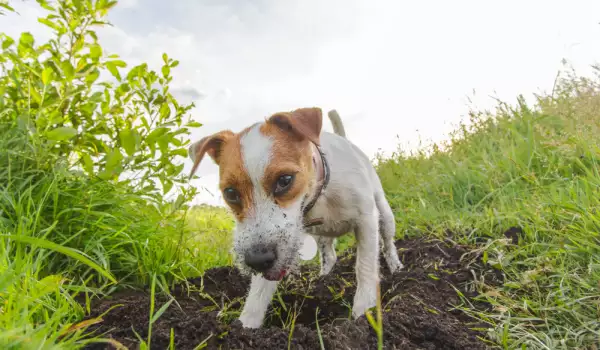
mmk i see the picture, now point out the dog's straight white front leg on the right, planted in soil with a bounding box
[352,209,379,318]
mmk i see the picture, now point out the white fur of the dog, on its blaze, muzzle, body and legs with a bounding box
[234,119,403,328]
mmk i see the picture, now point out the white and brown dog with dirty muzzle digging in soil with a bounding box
[189,107,403,328]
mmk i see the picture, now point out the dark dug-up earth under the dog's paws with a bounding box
[79,238,502,350]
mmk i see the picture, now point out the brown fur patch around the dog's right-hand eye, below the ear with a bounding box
[260,122,315,208]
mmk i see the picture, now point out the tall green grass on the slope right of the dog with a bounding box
[378,67,600,349]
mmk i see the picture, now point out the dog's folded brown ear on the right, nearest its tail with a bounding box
[267,107,323,145]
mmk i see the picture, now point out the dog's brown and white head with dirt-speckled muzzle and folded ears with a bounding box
[189,108,322,280]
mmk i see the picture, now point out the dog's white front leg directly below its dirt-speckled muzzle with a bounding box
[239,275,277,328]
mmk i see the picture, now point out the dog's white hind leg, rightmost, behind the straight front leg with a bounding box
[375,193,404,273]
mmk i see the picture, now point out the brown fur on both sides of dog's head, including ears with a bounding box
[190,108,322,221]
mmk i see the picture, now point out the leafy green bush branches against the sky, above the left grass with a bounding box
[0,0,202,198]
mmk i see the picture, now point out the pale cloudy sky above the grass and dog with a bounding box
[0,0,600,205]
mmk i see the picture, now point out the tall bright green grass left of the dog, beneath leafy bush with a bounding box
[0,120,230,348]
